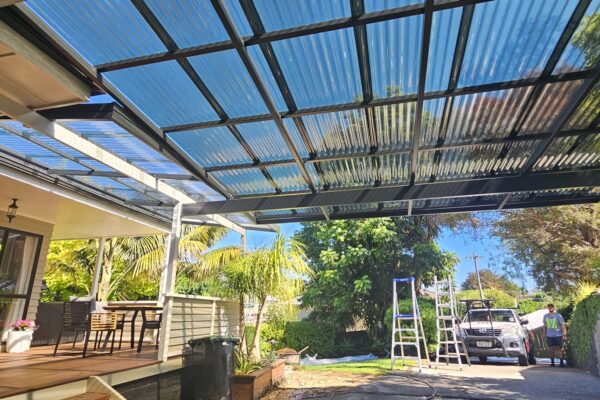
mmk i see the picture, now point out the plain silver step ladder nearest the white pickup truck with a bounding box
[433,276,471,371]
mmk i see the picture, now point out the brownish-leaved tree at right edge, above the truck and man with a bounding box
[493,204,600,291]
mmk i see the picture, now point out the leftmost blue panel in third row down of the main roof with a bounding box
[167,126,253,167]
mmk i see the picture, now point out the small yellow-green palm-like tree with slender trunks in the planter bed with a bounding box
[223,234,313,361]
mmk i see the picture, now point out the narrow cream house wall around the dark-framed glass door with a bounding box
[0,215,54,320]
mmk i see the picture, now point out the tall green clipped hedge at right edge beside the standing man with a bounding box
[567,294,600,373]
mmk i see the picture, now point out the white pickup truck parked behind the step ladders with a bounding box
[460,308,536,366]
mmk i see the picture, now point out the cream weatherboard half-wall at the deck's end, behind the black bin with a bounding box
[163,294,239,360]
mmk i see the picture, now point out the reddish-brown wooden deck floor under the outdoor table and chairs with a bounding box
[0,344,159,398]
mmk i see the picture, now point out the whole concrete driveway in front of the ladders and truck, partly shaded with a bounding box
[264,359,600,400]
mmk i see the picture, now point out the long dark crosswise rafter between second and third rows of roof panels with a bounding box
[158,70,594,133]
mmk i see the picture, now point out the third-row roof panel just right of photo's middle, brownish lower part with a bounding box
[302,109,371,156]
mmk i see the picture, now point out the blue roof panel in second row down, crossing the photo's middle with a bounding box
[273,29,362,108]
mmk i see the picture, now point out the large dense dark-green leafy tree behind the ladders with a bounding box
[296,217,457,340]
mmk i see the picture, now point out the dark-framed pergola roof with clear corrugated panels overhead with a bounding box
[0,0,600,226]
